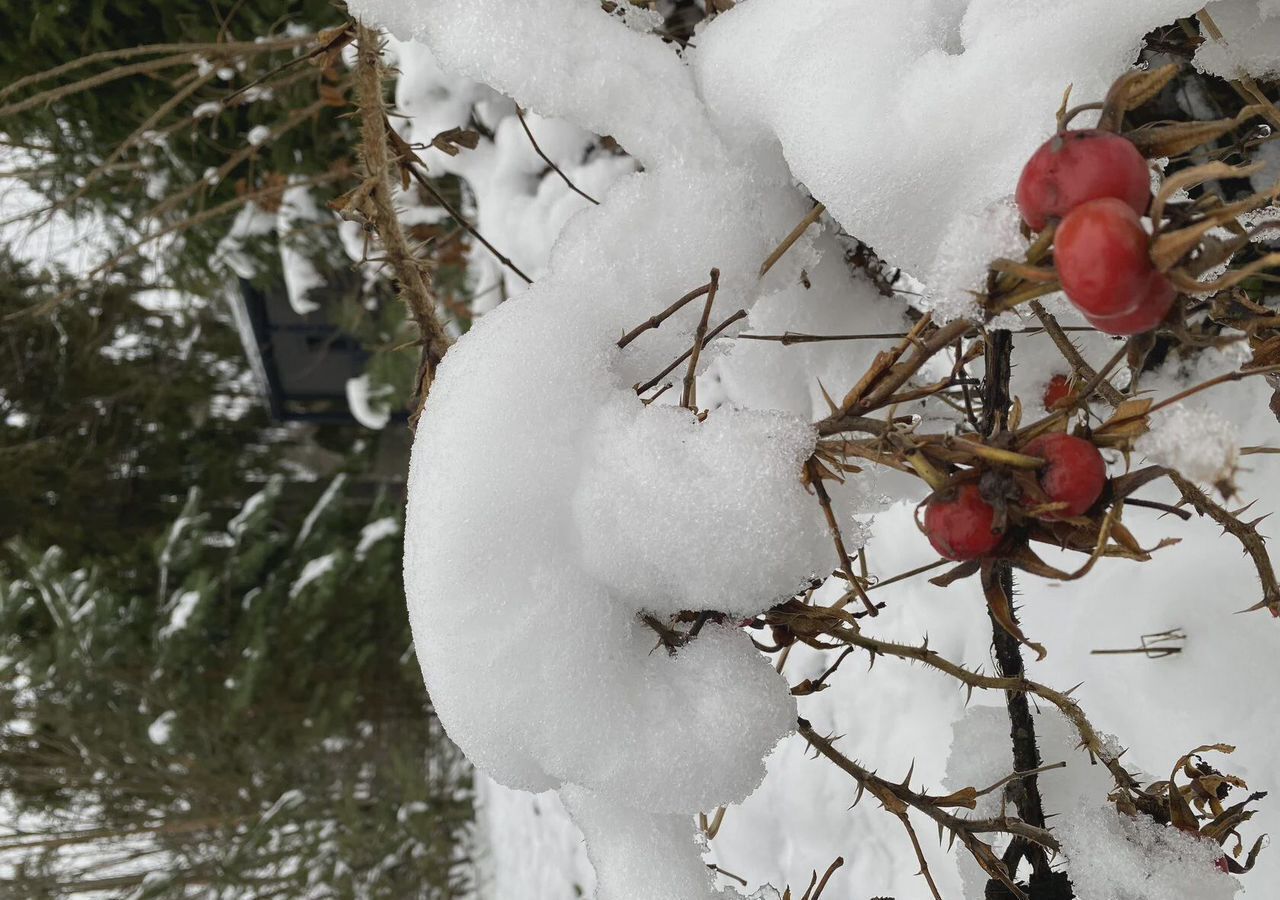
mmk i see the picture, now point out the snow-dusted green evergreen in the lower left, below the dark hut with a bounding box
[0,476,471,900]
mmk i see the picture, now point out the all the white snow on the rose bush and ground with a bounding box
[351,0,1280,900]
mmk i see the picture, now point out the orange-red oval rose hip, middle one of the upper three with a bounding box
[1053,197,1155,316]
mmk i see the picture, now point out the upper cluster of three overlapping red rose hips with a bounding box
[1016,129,1176,335]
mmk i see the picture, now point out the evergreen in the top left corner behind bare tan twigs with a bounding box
[0,0,356,289]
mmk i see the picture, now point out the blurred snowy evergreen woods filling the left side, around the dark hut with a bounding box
[0,0,472,900]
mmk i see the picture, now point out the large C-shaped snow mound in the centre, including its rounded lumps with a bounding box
[406,158,829,897]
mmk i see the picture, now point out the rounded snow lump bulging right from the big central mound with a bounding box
[573,396,826,617]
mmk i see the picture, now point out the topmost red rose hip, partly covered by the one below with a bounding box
[1016,129,1151,232]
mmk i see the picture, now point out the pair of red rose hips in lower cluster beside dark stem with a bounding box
[924,433,1107,561]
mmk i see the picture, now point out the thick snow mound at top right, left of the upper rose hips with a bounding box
[692,0,1202,274]
